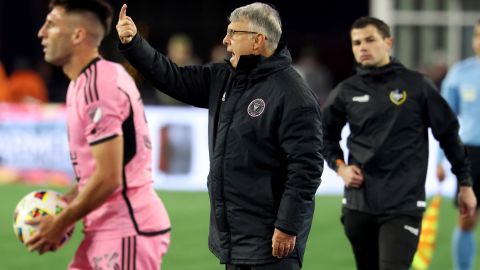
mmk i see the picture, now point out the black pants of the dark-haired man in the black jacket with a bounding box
[342,208,422,270]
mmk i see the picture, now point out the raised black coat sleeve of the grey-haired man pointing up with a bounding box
[119,34,211,108]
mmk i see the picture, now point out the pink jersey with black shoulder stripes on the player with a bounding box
[67,58,170,237]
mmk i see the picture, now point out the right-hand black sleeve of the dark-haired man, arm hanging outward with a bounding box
[424,78,472,186]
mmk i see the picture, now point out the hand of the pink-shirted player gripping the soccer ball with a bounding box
[25,215,66,255]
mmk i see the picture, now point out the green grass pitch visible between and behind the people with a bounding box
[0,182,480,270]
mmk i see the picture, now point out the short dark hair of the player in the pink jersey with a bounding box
[49,0,113,35]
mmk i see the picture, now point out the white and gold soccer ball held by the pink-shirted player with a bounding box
[13,190,74,247]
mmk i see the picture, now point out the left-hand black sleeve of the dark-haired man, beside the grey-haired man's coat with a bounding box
[322,84,347,171]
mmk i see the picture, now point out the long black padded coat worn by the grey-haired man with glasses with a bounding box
[120,36,323,264]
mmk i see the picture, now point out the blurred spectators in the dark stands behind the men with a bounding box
[0,31,448,106]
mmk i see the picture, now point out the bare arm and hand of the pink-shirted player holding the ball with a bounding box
[27,136,123,254]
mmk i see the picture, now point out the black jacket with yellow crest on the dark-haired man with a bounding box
[323,59,471,214]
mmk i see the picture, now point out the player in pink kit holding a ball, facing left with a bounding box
[27,0,170,270]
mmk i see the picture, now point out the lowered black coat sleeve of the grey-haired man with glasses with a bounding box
[274,103,323,235]
